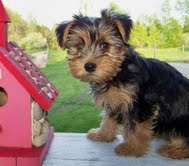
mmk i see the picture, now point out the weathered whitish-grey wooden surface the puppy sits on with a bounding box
[43,133,189,166]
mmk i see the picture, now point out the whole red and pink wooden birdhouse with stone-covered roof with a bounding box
[0,0,58,166]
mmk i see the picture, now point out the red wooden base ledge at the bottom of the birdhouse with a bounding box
[0,128,54,166]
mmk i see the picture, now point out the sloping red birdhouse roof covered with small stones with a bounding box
[0,42,58,110]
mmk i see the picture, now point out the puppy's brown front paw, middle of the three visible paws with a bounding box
[114,143,145,157]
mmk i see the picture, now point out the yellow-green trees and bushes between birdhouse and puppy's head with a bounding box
[6,8,58,49]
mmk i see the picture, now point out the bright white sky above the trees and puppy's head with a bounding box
[2,0,166,28]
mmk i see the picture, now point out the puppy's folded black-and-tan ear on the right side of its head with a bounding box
[114,15,133,44]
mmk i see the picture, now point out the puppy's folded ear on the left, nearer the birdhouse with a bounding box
[55,21,75,48]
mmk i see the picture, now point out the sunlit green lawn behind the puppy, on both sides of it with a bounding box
[42,48,189,132]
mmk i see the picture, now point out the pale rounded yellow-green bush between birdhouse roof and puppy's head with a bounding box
[18,32,47,50]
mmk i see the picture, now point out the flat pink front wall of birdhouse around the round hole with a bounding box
[0,61,32,148]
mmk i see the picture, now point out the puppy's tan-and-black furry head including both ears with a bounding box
[56,10,132,83]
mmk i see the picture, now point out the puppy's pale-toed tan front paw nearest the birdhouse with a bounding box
[87,128,116,142]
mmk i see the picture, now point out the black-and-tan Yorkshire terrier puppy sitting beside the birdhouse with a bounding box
[56,10,189,159]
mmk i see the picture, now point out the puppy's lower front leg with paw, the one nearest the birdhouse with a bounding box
[87,114,117,142]
